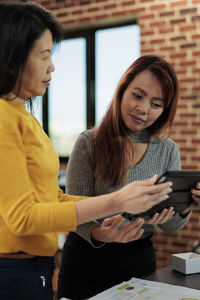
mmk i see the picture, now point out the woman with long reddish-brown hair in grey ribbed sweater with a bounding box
[58,56,198,299]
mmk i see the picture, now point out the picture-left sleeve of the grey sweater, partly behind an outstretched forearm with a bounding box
[66,131,104,247]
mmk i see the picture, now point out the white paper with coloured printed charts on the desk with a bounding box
[90,277,200,300]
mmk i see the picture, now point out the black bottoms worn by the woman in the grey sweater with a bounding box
[58,233,156,300]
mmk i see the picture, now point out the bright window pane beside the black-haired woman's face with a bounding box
[49,38,86,156]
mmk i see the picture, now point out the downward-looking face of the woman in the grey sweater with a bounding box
[121,70,164,131]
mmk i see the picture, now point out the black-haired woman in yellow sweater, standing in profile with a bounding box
[0,3,171,300]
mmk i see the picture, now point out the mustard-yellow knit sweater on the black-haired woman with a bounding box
[0,99,84,256]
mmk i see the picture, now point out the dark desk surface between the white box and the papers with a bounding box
[143,266,200,290]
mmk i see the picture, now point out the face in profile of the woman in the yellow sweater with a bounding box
[13,29,54,100]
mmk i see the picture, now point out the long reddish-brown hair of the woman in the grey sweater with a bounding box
[91,55,179,186]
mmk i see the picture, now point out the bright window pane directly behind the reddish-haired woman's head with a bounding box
[95,25,140,124]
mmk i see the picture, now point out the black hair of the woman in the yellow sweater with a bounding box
[0,2,62,96]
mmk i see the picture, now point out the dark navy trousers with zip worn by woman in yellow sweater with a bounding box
[0,256,54,300]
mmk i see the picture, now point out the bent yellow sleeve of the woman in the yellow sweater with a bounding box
[0,112,89,236]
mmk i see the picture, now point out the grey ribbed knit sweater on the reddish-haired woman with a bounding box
[66,130,190,247]
